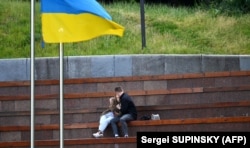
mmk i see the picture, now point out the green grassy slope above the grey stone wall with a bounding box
[0,0,250,58]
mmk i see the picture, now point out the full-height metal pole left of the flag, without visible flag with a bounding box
[30,0,35,148]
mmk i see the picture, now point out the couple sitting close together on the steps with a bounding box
[93,87,137,138]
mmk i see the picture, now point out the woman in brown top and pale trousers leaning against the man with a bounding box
[93,97,120,138]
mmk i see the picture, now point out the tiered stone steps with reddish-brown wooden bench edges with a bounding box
[0,71,250,148]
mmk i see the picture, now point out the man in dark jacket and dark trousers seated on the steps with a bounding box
[110,87,137,138]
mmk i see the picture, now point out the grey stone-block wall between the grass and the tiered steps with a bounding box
[0,54,250,81]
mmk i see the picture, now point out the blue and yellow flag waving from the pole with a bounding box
[41,0,124,43]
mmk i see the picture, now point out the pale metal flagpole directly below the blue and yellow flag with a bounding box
[60,42,64,148]
